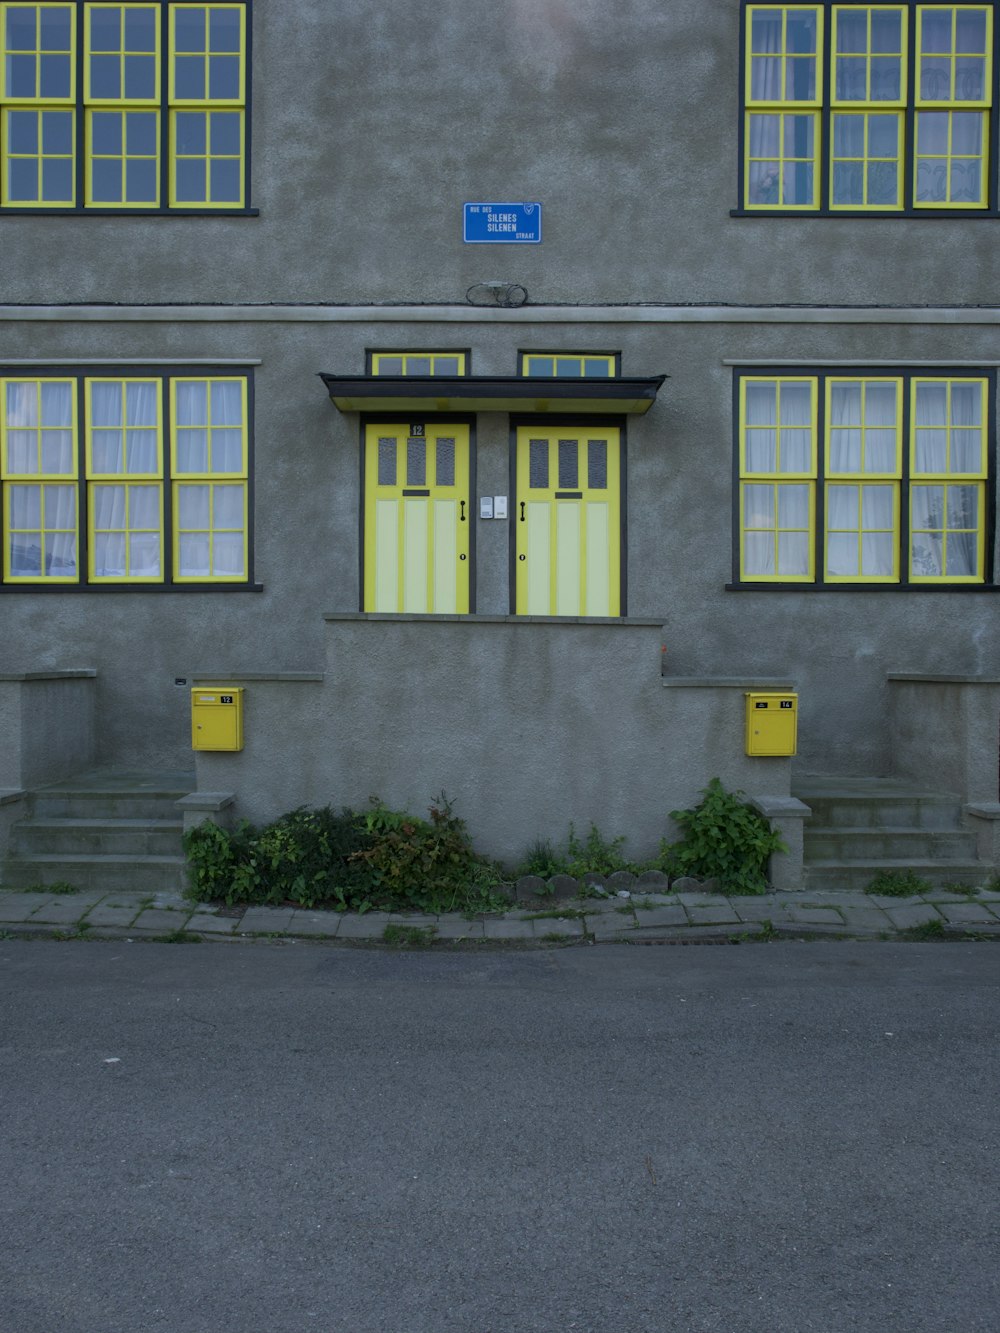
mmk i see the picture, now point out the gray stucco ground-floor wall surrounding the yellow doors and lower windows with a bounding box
[0,311,1000,782]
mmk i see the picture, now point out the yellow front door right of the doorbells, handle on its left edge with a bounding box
[513,427,621,616]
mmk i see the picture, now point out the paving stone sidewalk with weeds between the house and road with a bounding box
[0,889,1000,948]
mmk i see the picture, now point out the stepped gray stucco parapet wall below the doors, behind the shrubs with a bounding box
[197,616,791,861]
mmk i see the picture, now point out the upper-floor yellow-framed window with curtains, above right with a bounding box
[741,0,997,215]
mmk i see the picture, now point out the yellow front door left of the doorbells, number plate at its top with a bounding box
[364,421,472,615]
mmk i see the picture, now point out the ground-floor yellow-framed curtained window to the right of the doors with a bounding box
[736,369,996,585]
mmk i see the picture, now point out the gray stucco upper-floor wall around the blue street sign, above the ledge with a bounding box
[3,0,1000,304]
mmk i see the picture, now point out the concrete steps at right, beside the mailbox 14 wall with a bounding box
[795,777,993,892]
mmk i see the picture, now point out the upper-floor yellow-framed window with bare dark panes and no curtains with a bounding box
[0,0,249,212]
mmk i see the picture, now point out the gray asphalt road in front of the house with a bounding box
[0,941,1000,1333]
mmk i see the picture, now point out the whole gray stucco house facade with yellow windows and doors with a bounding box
[0,0,1000,874]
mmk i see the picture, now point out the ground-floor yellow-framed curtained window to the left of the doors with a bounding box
[0,369,251,587]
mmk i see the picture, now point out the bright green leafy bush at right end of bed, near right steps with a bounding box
[660,777,788,893]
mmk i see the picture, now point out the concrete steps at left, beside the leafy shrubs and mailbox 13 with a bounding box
[0,770,195,893]
